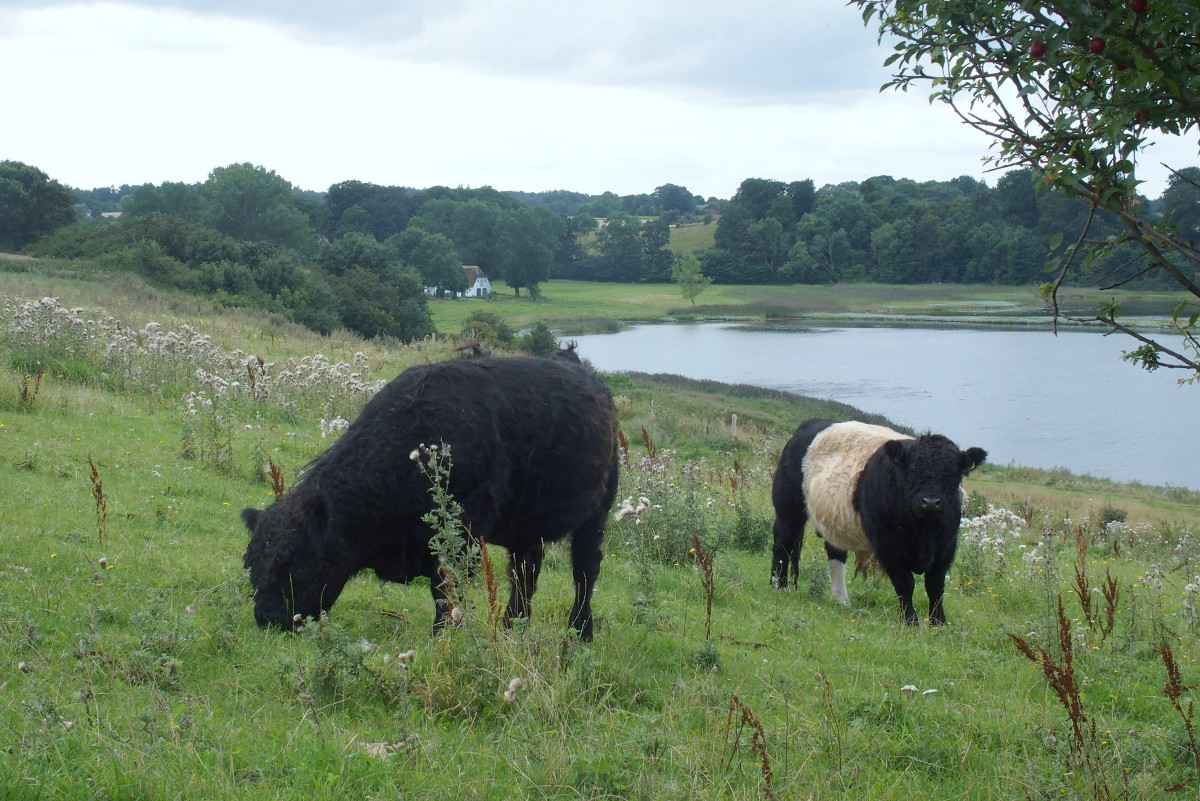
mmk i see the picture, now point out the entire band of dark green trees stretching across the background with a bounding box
[0,162,1200,341]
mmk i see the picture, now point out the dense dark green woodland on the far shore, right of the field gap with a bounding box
[700,168,1200,288]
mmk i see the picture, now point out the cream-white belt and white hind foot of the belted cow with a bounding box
[803,422,912,553]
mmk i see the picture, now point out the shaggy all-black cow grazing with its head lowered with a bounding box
[241,345,619,640]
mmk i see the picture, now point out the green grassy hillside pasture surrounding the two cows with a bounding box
[0,266,1200,800]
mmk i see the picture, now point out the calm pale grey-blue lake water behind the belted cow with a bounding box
[572,324,1200,489]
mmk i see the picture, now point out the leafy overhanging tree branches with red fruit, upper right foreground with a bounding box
[852,0,1200,380]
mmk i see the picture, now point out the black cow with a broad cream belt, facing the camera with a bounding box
[770,420,988,625]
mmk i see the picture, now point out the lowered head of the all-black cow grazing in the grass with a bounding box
[241,494,350,630]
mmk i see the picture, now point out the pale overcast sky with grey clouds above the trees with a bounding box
[0,0,1200,198]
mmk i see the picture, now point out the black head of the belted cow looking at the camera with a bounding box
[883,434,988,519]
